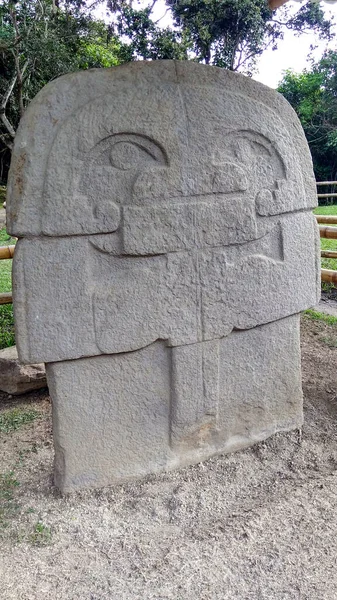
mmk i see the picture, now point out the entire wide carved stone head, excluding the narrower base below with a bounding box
[9,63,316,362]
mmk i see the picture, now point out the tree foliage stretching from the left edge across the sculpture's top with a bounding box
[0,0,337,182]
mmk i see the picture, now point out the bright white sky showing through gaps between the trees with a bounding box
[96,0,337,88]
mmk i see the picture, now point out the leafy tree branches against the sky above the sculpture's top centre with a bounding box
[107,0,331,75]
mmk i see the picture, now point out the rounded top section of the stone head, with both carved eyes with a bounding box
[7,61,316,236]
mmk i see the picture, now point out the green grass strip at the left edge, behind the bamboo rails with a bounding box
[0,228,16,349]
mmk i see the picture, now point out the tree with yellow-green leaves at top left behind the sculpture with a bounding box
[0,0,119,180]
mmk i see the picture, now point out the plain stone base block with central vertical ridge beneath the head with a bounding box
[47,315,303,492]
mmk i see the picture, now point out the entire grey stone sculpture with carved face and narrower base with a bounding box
[7,61,319,491]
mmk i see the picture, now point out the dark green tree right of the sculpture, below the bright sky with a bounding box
[278,51,337,191]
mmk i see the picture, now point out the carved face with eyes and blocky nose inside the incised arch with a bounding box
[41,81,305,247]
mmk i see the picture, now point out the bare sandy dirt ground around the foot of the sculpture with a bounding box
[0,317,337,600]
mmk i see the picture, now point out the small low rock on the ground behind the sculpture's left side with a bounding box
[0,346,47,395]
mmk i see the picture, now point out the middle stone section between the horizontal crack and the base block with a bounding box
[14,212,317,363]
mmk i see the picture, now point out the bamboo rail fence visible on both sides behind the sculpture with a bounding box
[0,181,337,304]
